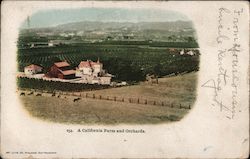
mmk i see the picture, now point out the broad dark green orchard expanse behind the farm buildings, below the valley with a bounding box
[18,38,199,81]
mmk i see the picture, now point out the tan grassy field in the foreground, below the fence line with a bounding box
[21,96,188,124]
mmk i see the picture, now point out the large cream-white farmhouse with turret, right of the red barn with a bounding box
[76,59,113,85]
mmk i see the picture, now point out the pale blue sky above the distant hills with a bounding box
[21,8,189,28]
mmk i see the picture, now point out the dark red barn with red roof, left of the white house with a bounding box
[47,61,75,79]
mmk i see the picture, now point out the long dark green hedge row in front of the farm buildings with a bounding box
[17,77,111,92]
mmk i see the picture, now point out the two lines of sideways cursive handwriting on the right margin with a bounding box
[201,7,244,119]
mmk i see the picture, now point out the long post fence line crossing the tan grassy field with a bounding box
[20,89,191,109]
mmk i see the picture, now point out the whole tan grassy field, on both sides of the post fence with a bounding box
[20,73,197,124]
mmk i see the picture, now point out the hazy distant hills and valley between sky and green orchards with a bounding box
[19,21,196,42]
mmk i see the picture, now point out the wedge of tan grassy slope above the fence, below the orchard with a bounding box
[84,73,197,105]
